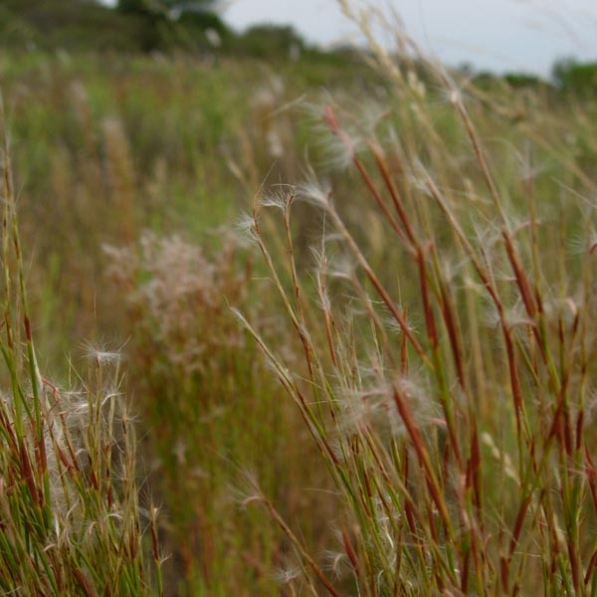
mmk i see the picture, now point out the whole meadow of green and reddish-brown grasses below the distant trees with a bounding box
[0,11,597,597]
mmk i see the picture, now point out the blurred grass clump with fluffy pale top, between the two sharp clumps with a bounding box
[106,227,338,595]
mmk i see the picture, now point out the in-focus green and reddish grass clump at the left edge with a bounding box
[0,96,162,597]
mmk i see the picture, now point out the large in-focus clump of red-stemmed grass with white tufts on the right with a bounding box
[239,7,597,596]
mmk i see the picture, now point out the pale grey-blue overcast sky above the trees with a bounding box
[223,0,597,75]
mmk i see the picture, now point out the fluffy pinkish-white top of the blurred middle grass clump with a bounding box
[105,231,252,377]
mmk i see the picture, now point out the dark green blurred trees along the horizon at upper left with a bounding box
[0,0,342,59]
